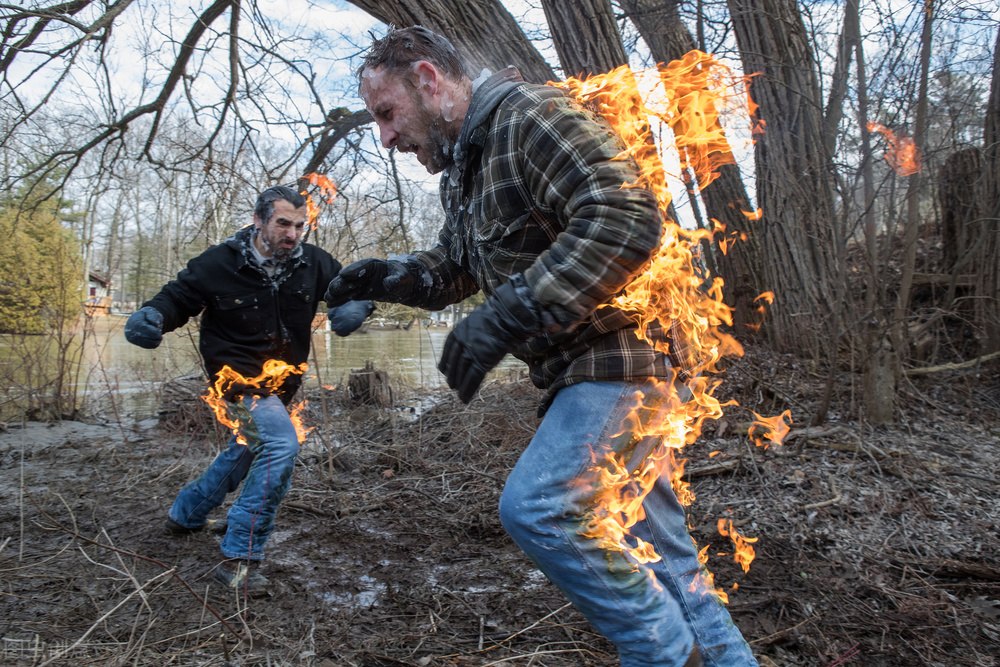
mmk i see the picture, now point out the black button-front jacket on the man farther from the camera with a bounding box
[143,227,340,404]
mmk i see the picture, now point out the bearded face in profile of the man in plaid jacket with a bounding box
[361,67,456,174]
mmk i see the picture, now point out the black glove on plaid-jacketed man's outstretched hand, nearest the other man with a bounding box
[323,259,423,308]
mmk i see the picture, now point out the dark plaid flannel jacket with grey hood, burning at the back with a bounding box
[416,68,673,412]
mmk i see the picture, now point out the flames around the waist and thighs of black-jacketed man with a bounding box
[202,359,312,445]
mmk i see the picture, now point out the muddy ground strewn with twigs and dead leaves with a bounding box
[0,352,1000,667]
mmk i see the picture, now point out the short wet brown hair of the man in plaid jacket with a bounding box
[357,25,469,92]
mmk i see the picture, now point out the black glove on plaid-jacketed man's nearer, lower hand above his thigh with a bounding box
[438,274,542,403]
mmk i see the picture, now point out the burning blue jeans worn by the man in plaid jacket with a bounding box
[500,382,757,667]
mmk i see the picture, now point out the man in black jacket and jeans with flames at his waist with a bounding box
[125,185,374,595]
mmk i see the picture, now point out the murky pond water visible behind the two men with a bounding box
[0,316,525,418]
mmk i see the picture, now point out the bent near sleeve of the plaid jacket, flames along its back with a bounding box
[518,98,662,327]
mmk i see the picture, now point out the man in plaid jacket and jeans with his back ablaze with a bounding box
[325,26,757,667]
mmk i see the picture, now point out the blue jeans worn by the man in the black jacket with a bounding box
[169,396,299,560]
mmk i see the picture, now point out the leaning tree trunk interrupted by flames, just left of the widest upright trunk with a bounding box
[619,0,764,332]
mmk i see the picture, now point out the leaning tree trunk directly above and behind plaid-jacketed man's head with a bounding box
[348,0,556,83]
